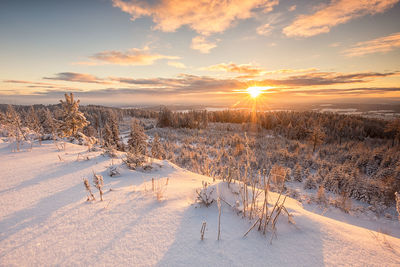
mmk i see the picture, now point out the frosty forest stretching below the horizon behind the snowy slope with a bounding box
[0,94,400,215]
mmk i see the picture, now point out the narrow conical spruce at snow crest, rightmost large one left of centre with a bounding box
[126,119,147,169]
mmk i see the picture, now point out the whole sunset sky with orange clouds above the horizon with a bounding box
[0,0,400,106]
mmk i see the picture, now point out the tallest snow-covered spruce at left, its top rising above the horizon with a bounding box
[60,93,89,137]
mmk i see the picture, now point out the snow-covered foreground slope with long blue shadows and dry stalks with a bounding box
[0,142,400,266]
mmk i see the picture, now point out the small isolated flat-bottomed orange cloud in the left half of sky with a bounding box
[76,47,179,66]
